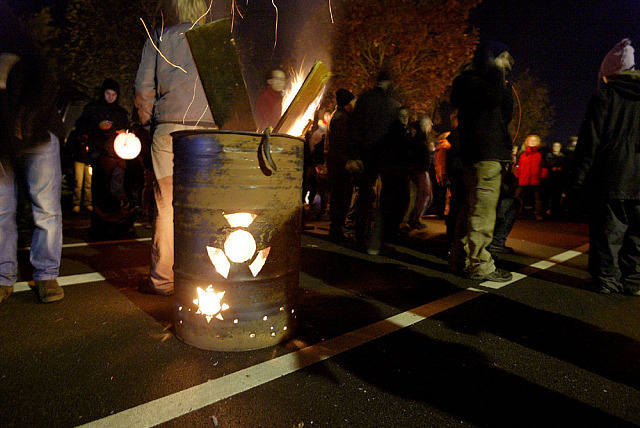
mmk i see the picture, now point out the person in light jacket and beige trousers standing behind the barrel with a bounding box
[135,0,215,295]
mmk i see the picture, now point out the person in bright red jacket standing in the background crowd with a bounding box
[515,135,548,221]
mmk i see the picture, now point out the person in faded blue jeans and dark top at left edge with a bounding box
[0,3,64,303]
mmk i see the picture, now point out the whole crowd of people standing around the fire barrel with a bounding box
[0,0,640,303]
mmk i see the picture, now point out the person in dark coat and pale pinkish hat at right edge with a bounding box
[569,39,640,296]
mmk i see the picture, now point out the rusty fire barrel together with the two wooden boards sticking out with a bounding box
[172,20,330,351]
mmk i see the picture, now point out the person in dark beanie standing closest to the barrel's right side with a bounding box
[324,88,356,243]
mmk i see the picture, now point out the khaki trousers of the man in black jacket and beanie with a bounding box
[449,161,502,275]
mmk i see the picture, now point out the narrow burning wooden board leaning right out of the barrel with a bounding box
[273,61,331,134]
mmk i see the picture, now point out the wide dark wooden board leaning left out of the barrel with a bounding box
[184,18,256,131]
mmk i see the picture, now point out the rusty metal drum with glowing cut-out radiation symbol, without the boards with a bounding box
[172,131,304,351]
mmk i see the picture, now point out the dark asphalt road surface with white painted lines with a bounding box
[0,212,640,428]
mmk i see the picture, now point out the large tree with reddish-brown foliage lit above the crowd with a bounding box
[331,0,480,113]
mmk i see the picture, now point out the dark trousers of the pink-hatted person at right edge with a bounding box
[589,198,640,292]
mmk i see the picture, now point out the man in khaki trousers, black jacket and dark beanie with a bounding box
[449,42,513,282]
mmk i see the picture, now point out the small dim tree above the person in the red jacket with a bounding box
[509,69,555,147]
